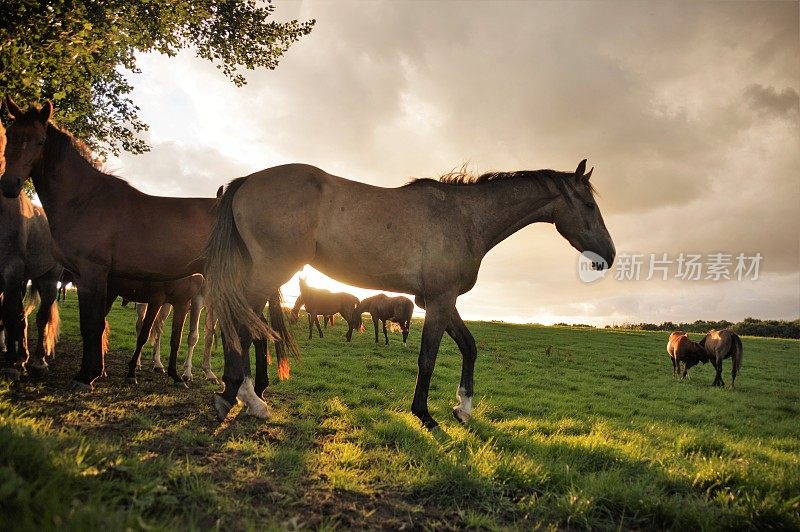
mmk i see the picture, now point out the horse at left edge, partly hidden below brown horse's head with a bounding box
[0,194,62,381]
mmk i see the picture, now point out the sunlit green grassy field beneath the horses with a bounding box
[0,293,800,530]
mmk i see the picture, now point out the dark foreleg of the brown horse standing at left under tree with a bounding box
[70,264,108,391]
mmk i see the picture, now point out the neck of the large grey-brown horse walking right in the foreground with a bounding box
[458,178,556,254]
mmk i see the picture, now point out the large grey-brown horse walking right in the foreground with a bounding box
[206,161,616,428]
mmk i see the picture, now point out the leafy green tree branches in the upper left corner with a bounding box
[0,0,314,155]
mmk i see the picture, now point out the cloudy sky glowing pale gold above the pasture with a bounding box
[106,0,800,326]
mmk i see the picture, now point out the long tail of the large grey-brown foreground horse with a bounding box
[205,177,277,353]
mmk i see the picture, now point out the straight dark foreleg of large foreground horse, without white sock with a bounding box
[411,299,455,430]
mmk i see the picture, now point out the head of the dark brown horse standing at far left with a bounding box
[0,96,53,198]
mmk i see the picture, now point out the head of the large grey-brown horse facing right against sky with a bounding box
[554,159,617,269]
